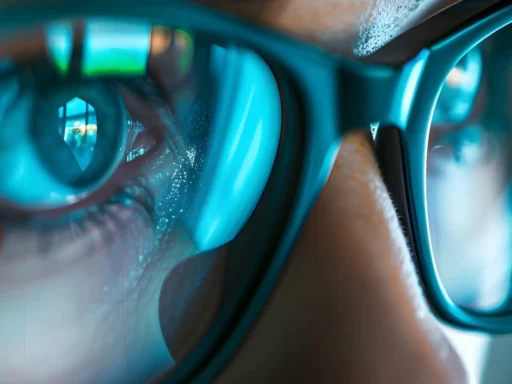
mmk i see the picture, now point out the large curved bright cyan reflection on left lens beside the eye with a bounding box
[186,46,281,252]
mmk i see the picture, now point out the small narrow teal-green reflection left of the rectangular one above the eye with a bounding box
[46,23,73,75]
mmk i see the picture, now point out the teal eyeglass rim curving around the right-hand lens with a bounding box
[401,6,512,334]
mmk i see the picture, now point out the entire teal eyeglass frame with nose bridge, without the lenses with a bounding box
[0,0,512,382]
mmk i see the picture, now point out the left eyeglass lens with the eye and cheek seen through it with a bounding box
[0,18,282,382]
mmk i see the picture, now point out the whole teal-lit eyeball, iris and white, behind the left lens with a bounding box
[0,77,126,207]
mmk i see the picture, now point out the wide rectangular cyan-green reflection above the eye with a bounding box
[82,19,151,76]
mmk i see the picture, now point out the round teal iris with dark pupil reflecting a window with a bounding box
[33,81,127,192]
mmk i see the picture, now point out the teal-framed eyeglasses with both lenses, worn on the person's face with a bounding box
[0,0,512,382]
